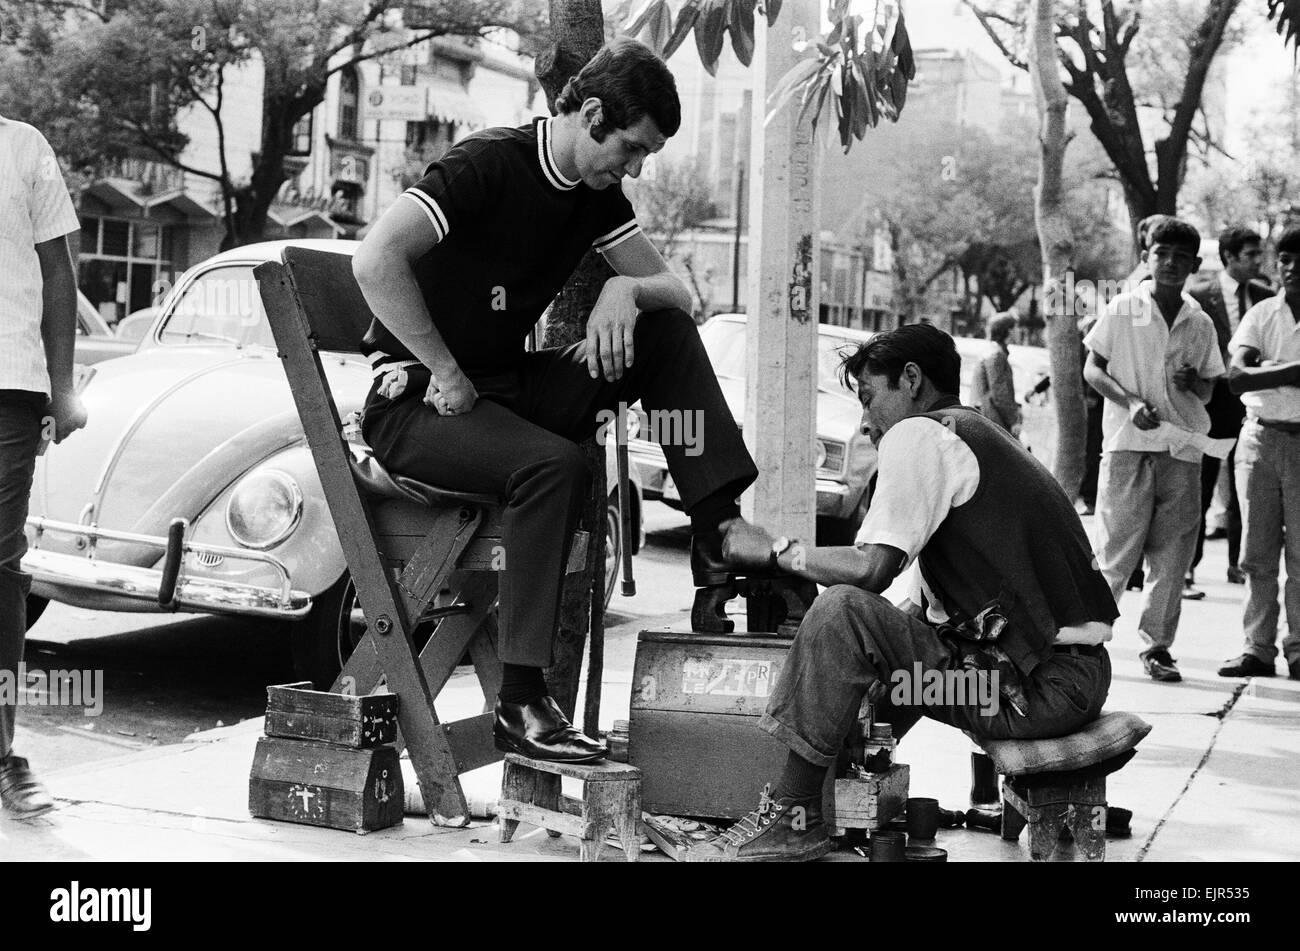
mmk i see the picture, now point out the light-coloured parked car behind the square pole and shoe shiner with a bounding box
[629,314,876,544]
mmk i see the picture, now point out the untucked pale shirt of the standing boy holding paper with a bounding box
[1083,281,1226,463]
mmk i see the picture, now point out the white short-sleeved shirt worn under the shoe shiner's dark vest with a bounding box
[854,416,1112,644]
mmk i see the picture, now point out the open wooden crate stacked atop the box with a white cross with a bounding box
[267,682,398,750]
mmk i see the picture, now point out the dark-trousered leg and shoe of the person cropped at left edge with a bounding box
[0,391,53,818]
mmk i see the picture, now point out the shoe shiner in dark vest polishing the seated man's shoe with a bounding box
[688,323,1119,861]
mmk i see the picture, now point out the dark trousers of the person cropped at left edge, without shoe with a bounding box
[0,390,47,756]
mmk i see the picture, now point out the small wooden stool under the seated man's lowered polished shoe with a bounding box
[497,754,641,861]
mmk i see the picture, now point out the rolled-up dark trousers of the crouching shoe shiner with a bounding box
[759,585,1110,767]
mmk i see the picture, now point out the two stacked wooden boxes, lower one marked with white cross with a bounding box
[248,682,404,833]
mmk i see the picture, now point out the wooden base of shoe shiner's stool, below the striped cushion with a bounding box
[1002,774,1106,861]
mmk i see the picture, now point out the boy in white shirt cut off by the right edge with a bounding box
[1219,226,1300,679]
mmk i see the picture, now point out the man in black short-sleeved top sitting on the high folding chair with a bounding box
[354,39,758,763]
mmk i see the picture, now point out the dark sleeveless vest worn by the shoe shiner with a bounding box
[918,398,1119,674]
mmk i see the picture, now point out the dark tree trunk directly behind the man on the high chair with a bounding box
[537,0,614,735]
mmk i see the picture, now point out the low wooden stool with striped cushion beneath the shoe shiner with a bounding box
[967,712,1151,861]
